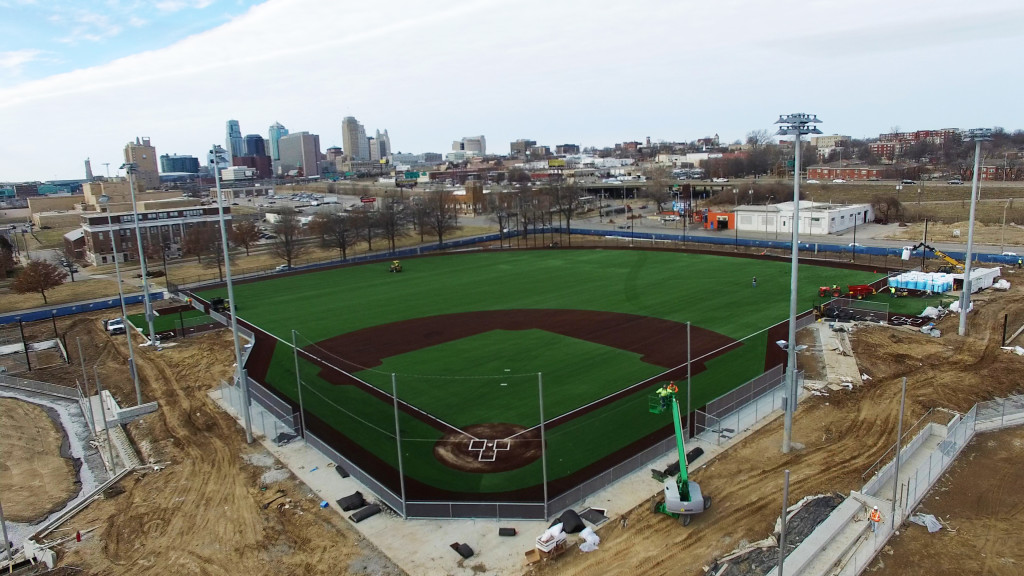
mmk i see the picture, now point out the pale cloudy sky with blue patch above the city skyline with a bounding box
[0,0,1024,181]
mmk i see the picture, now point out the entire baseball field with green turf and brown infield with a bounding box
[199,248,881,501]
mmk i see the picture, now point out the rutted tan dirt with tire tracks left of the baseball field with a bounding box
[49,321,401,576]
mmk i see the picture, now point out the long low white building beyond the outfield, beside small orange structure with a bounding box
[733,200,874,240]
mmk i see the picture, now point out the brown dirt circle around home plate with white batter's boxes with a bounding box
[434,422,541,472]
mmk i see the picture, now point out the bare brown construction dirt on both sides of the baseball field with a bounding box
[5,271,1024,576]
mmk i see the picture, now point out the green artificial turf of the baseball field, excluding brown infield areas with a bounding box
[200,249,880,493]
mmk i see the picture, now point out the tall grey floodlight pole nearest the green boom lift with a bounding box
[775,113,821,454]
